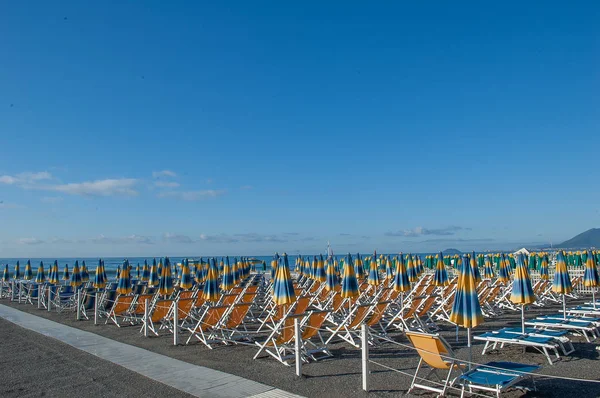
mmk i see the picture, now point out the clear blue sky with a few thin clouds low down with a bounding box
[0,1,600,257]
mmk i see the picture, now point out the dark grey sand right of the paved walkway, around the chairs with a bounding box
[0,300,600,397]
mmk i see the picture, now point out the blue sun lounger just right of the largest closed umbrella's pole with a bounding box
[473,330,562,365]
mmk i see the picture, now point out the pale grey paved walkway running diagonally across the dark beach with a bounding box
[0,304,297,398]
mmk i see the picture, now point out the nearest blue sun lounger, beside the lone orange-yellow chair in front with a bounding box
[457,362,540,397]
